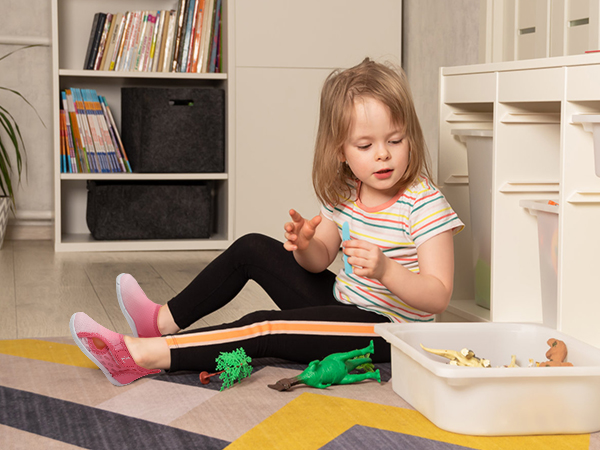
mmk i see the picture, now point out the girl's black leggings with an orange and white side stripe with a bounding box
[167,234,390,371]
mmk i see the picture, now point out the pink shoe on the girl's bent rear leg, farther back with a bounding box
[117,273,161,337]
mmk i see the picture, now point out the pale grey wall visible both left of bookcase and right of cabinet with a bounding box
[0,0,479,243]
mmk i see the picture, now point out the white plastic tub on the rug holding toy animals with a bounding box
[375,322,600,436]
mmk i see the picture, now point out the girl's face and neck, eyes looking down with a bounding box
[341,97,409,206]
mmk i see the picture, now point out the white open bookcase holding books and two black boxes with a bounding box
[52,0,235,252]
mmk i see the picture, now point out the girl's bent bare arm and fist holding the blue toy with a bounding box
[344,230,454,314]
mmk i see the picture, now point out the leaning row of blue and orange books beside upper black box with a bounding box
[60,88,131,173]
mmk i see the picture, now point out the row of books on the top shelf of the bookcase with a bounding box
[83,0,222,73]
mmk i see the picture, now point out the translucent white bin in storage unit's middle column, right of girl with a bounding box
[519,200,558,328]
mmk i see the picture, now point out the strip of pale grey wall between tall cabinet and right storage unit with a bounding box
[402,0,480,183]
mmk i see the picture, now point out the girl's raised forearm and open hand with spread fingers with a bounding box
[283,209,341,273]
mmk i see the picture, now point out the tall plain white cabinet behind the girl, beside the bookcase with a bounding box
[235,0,402,239]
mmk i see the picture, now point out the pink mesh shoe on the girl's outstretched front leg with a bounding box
[69,312,160,386]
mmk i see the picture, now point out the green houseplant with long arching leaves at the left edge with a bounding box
[0,45,44,248]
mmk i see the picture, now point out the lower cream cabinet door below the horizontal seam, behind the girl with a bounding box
[235,68,329,239]
